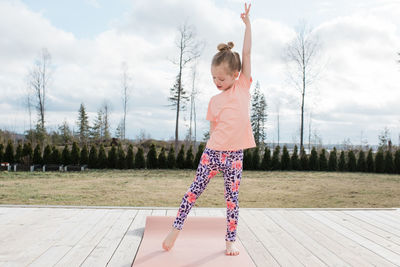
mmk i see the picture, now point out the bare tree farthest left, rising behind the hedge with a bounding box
[29,48,51,140]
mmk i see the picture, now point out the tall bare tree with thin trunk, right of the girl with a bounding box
[285,20,319,151]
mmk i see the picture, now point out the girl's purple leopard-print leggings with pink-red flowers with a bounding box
[173,147,243,241]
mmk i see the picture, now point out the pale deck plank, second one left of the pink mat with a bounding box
[80,210,139,266]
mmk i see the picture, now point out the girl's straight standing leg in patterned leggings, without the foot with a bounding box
[223,149,243,241]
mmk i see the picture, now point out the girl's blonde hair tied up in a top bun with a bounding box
[211,42,242,74]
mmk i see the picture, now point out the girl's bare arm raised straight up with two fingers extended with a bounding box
[240,3,251,79]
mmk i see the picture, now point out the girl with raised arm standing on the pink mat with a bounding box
[162,4,256,255]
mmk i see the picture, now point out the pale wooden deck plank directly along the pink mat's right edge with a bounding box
[238,209,301,266]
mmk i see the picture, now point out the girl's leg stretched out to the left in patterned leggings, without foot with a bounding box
[172,147,218,230]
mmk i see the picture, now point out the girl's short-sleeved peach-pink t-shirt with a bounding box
[206,73,256,150]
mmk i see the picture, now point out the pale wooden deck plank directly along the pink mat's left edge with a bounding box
[107,210,152,267]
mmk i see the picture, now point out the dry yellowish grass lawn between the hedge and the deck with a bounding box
[0,170,400,208]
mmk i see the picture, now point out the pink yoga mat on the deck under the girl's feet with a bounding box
[132,216,255,267]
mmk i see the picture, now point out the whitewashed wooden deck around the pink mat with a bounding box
[0,205,400,267]
